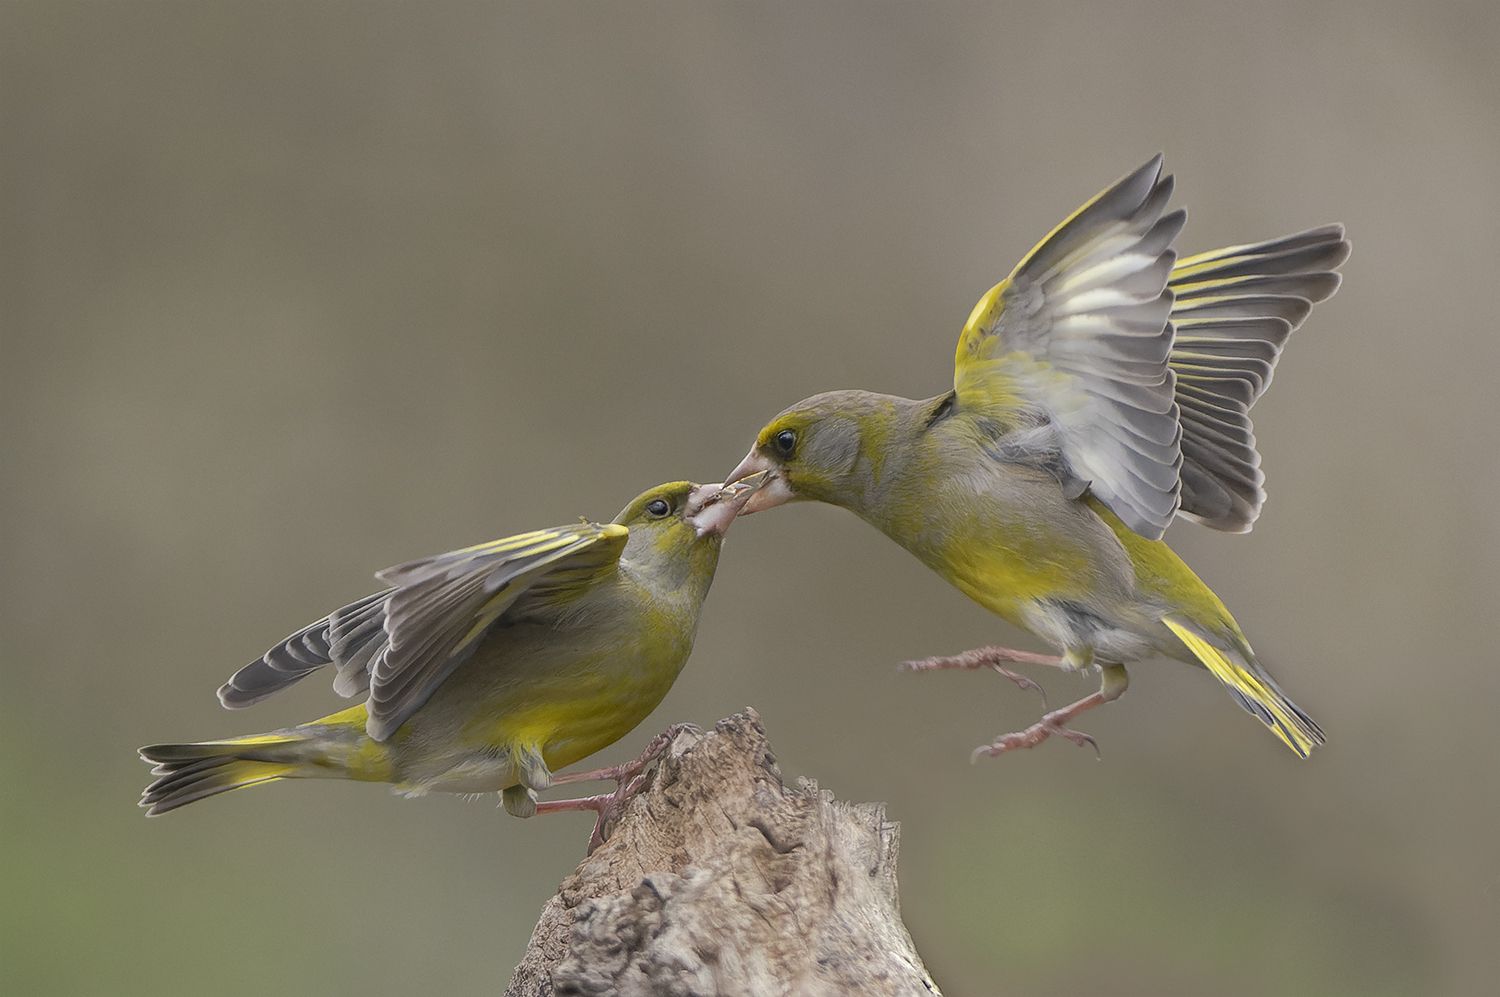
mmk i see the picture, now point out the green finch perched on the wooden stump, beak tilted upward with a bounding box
[141,481,756,838]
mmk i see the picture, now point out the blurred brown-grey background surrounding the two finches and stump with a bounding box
[0,1,1500,997]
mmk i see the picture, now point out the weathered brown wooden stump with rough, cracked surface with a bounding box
[506,709,939,997]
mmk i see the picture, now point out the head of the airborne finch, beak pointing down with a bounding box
[726,391,899,516]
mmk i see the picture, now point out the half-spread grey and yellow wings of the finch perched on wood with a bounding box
[219,522,630,741]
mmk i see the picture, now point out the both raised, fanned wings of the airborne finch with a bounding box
[954,163,1350,538]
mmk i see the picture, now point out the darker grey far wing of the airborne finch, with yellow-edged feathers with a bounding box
[1167,225,1349,534]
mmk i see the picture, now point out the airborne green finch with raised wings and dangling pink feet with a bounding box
[729,156,1349,757]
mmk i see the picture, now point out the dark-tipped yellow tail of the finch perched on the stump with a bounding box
[141,732,308,817]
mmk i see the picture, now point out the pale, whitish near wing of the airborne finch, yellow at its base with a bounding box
[954,156,1187,540]
